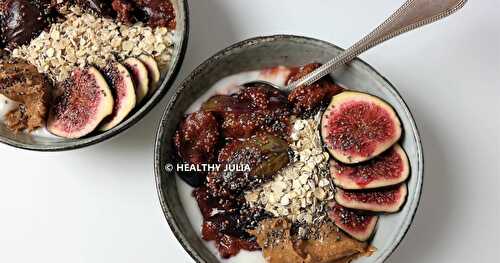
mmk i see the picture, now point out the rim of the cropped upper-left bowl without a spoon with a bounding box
[0,0,190,152]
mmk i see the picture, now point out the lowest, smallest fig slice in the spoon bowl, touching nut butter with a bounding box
[328,202,378,241]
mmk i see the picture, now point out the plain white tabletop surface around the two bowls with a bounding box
[0,0,500,263]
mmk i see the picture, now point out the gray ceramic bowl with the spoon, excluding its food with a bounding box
[154,35,423,262]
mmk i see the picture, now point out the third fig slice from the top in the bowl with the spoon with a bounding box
[335,183,408,213]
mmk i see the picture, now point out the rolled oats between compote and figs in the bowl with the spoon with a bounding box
[245,115,334,227]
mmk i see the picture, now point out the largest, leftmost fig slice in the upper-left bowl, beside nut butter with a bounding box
[47,67,113,138]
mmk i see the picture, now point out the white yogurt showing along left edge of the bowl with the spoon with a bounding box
[176,66,291,263]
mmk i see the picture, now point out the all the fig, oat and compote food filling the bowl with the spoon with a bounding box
[173,63,409,263]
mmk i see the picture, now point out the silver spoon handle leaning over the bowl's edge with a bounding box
[287,0,467,90]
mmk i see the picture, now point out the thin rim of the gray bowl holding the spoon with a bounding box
[154,34,424,263]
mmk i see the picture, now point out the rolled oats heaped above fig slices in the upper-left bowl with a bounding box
[12,7,173,81]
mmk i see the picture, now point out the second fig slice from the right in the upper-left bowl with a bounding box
[123,58,149,104]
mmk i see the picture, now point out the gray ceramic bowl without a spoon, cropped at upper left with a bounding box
[0,0,189,151]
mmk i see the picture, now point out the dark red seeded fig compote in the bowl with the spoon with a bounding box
[174,86,291,258]
